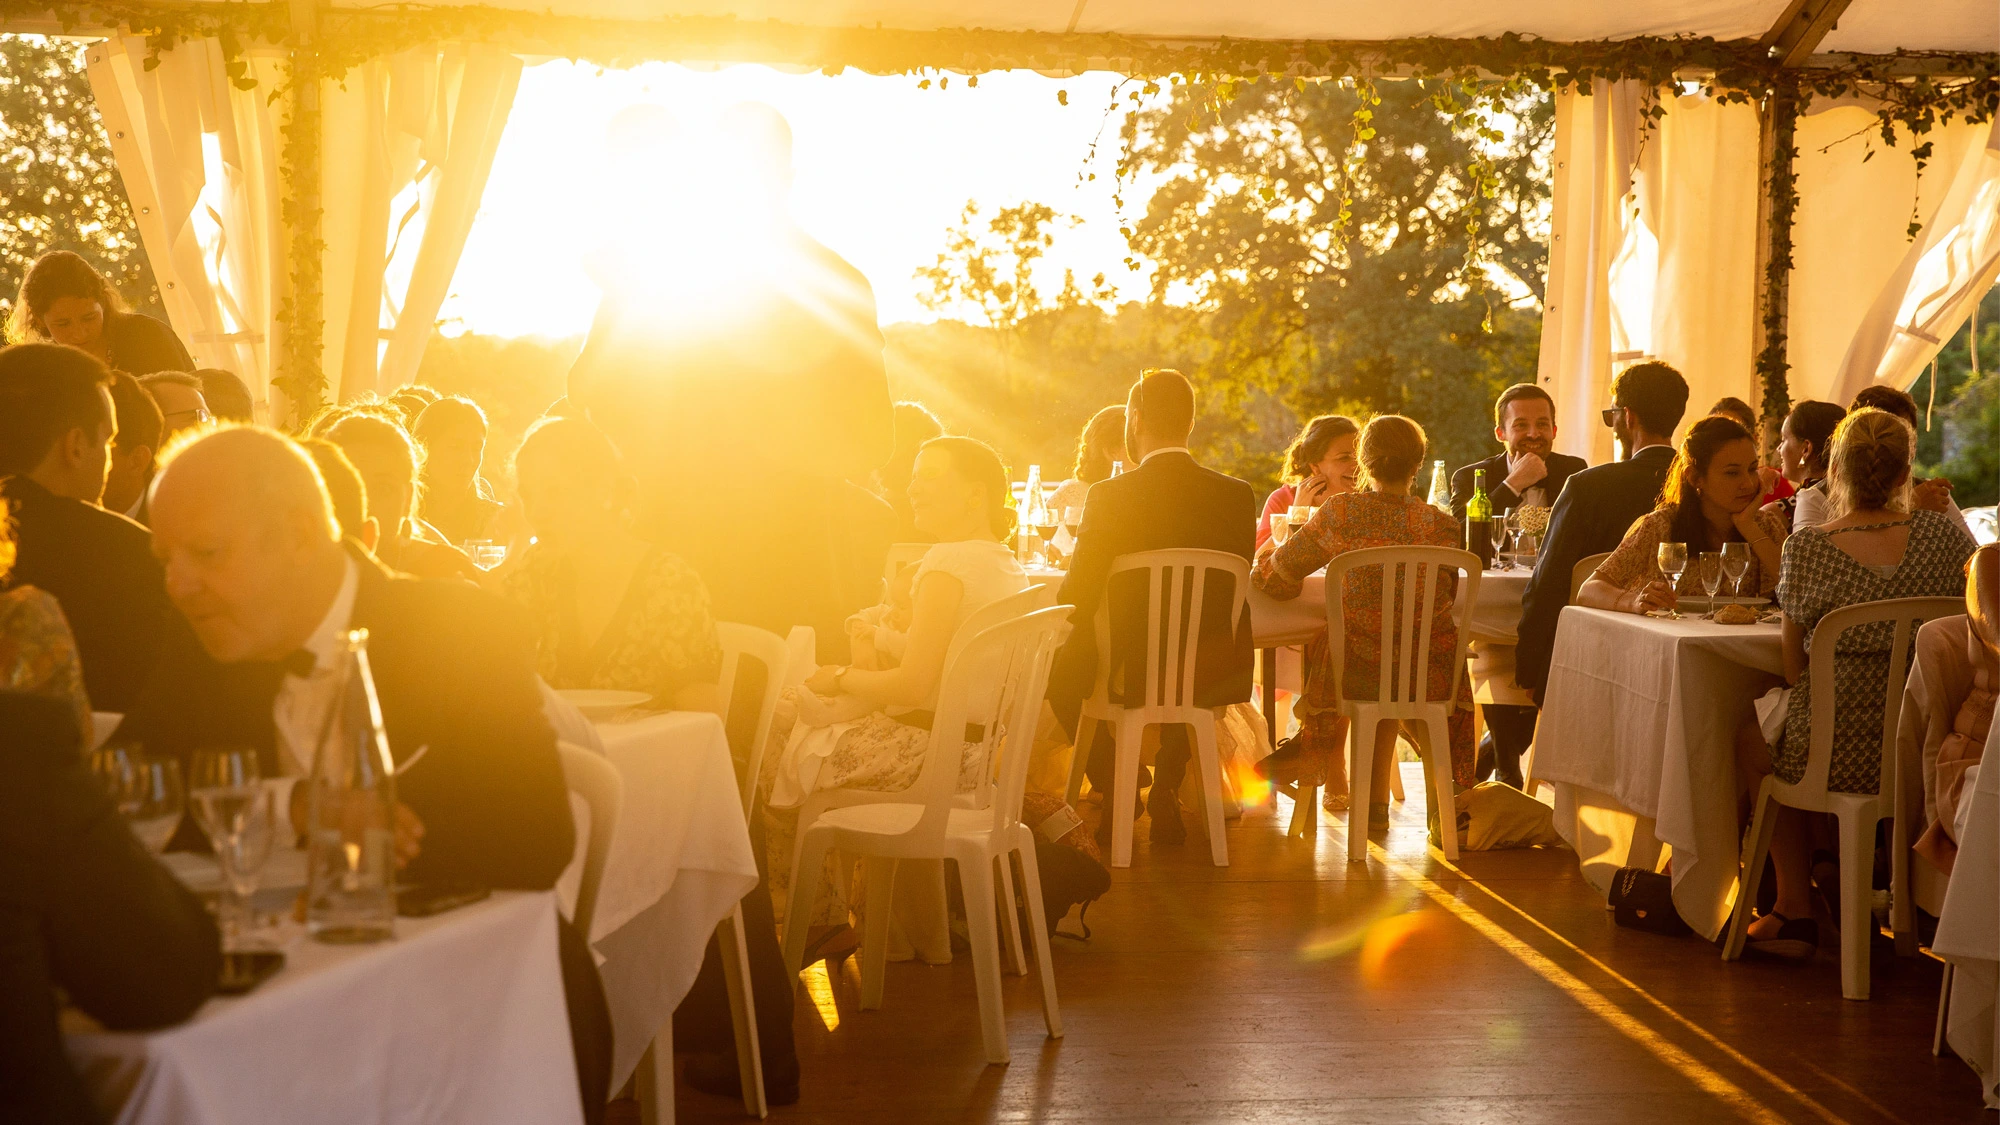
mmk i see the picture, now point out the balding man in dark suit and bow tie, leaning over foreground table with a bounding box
[120,426,610,1121]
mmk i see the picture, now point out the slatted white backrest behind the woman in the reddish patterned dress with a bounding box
[1326,546,1480,713]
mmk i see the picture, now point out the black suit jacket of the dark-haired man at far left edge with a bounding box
[0,476,174,711]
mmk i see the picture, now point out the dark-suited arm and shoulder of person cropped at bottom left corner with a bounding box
[0,693,222,1125]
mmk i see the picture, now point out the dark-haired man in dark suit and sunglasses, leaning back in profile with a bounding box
[1514,362,1688,700]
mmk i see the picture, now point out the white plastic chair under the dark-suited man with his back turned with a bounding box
[1068,548,1250,867]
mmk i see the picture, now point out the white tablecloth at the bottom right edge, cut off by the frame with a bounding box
[1936,723,2000,1109]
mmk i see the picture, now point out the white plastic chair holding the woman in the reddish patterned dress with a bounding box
[1326,546,1480,863]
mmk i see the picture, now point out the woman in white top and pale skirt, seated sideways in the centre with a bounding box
[762,436,1028,961]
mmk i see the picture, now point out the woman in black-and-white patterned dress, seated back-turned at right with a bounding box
[1736,408,1972,959]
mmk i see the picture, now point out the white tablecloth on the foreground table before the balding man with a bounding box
[68,891,582,1125]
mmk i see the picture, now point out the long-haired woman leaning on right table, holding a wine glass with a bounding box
[1576,414,1786,613]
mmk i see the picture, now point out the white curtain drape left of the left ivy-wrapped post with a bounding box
[84,38,286,404]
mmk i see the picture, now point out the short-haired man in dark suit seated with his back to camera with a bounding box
[1048,370,1258,843]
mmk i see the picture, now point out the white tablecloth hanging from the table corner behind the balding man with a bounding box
[590,711,756,1089]
